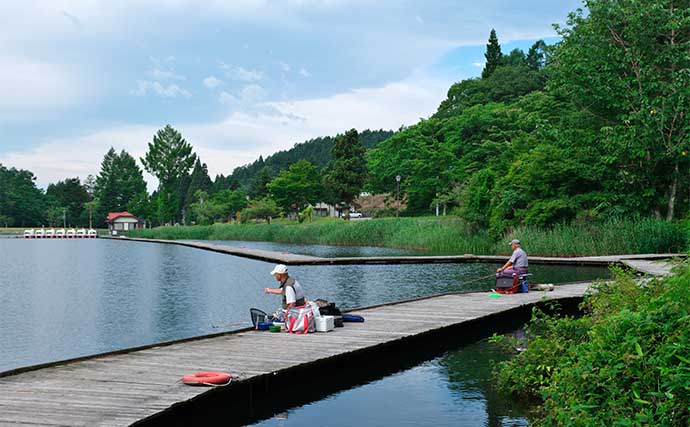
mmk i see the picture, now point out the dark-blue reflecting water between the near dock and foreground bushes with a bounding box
[247,342,529,427]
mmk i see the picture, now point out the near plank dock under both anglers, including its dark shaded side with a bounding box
[0,283,589,426]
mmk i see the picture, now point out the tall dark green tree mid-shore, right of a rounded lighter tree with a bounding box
[324,129,367,208]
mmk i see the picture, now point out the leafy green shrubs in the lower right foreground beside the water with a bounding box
[495,263,690,427]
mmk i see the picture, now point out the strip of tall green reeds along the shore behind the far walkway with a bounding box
[127,217,688,256]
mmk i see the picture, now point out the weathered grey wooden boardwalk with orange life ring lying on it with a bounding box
[0,283,589,426]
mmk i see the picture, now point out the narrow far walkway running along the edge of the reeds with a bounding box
[113,237,687,266]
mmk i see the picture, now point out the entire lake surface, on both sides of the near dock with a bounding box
[0,238,608,425]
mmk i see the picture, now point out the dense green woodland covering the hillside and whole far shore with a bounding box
[0,0,690,233]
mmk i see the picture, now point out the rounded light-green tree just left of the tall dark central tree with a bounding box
[268,160,323,216]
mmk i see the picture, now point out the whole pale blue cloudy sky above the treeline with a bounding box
[0,0,581,189]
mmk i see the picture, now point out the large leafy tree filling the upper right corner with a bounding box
[551,0,690,220]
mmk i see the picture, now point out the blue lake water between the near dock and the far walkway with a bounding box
[0,238,606,371]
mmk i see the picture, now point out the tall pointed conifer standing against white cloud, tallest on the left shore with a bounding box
[141,125,196,223]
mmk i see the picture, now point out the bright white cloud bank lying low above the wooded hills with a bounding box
[0,76,448,190]
